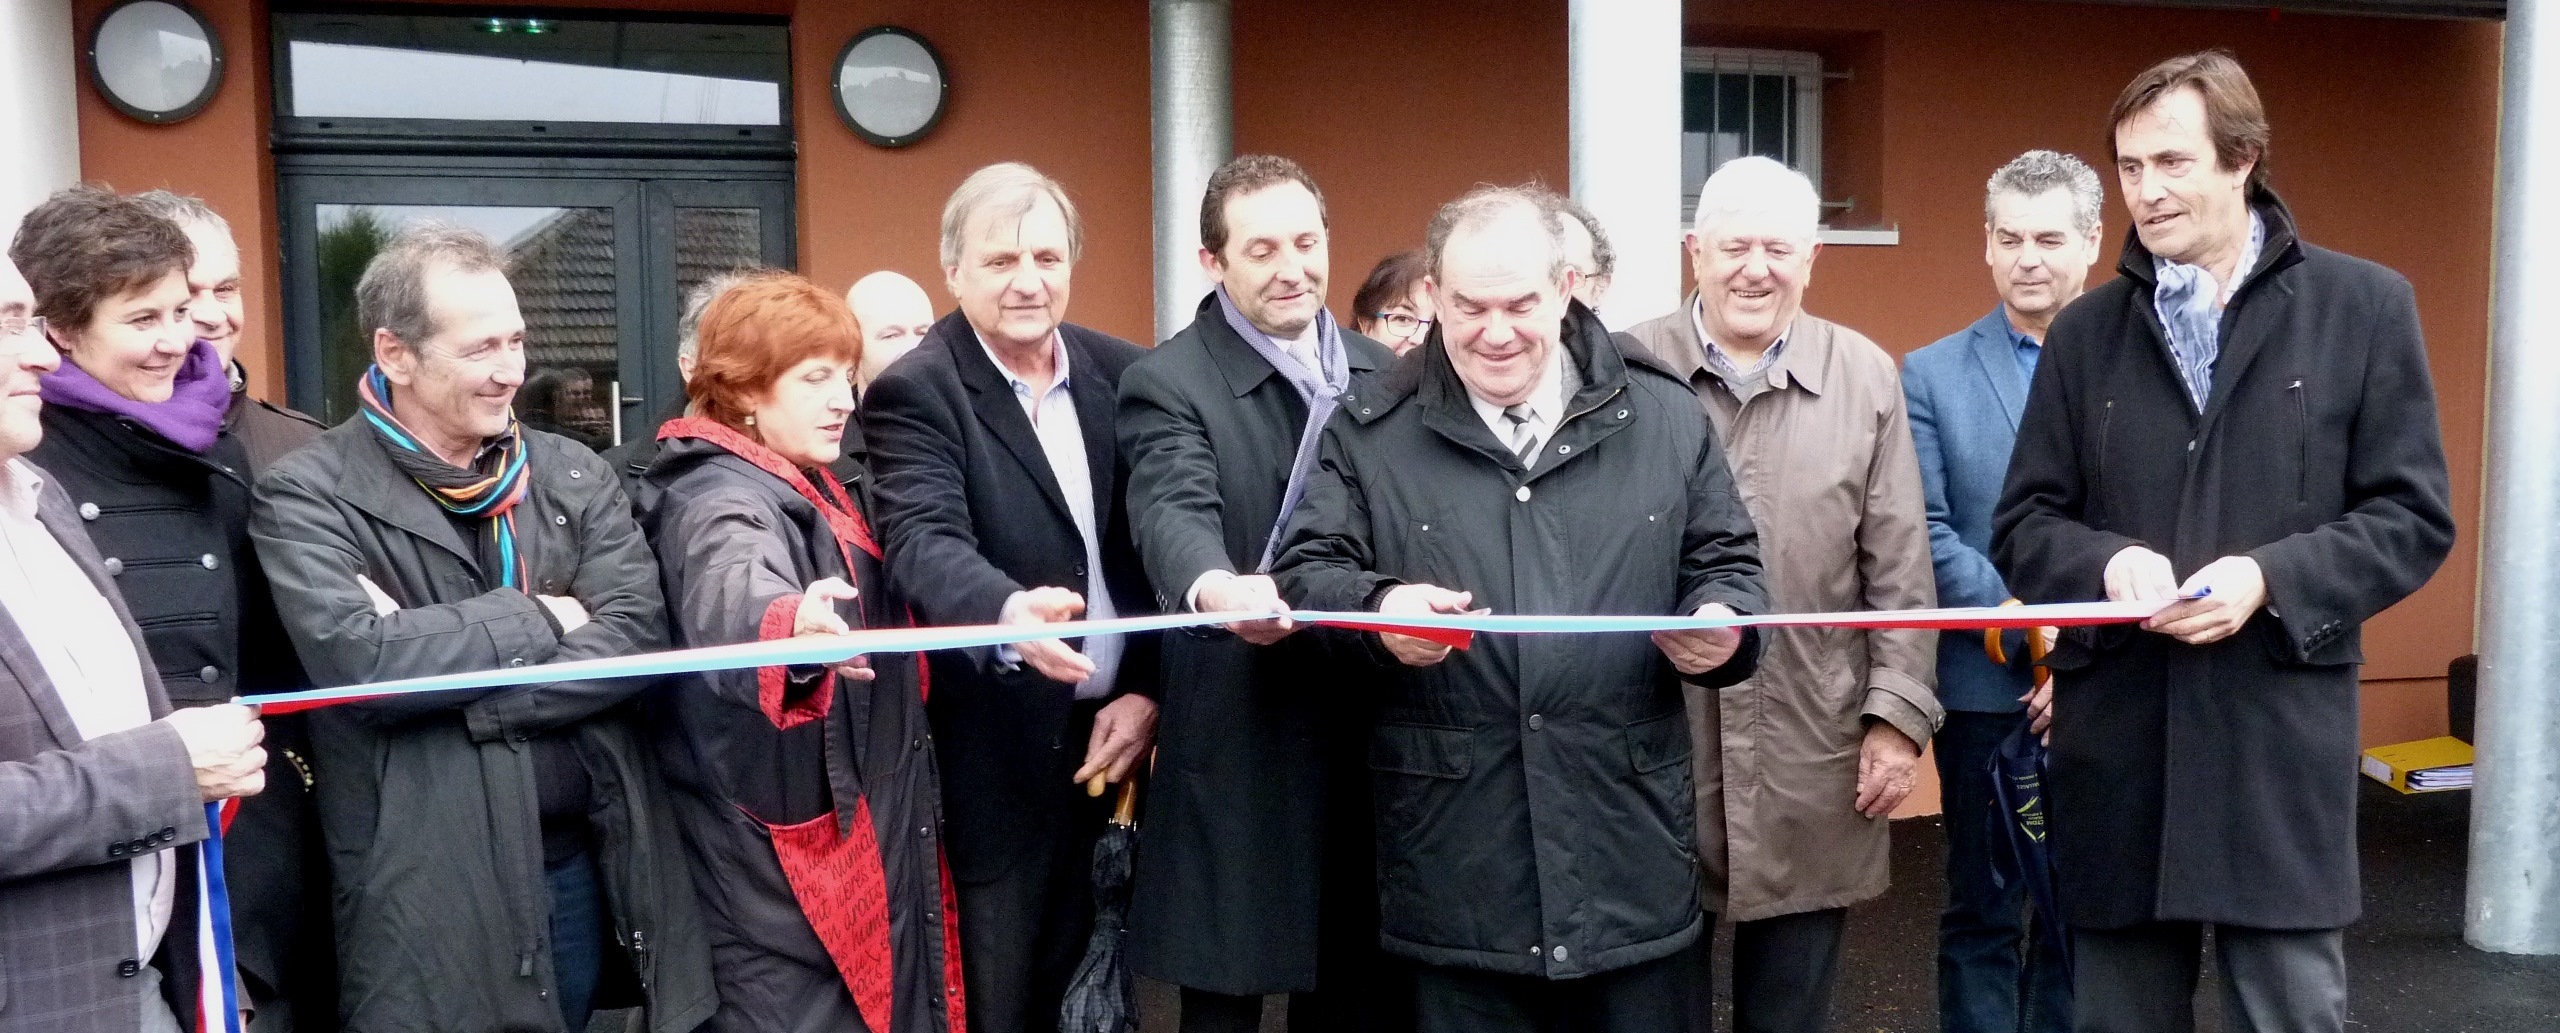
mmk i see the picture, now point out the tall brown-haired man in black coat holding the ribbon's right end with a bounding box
[1994,54,2452,1030]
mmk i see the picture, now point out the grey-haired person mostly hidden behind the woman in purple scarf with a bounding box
[133,189,323,476]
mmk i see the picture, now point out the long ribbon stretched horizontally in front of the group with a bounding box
[241,601,2168,713]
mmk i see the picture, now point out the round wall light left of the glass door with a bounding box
[90,0,223,125]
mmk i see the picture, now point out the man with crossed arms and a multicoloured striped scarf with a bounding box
[251,222,717,1033]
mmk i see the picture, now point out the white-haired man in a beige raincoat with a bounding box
[1631,156,1940,1033]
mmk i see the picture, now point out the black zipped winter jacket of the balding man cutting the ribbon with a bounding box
[1275,304,1766,979]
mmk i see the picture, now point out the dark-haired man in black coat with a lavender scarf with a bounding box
[1119,153,1405,1033]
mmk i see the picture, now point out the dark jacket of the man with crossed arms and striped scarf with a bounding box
[251,417,714,1033]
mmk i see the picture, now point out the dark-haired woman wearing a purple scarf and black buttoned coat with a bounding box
[10,187,328,1028]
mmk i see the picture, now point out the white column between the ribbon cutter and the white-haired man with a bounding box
[1567,0,1684,330]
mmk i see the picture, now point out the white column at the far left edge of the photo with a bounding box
[0,0,82,227]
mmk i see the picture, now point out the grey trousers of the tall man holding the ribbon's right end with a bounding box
[2071,923,2348,1033]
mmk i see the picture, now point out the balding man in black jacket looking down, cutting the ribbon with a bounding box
[1277,187,1764,1033]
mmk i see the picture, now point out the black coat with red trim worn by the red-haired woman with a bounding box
[643,427,960,1033]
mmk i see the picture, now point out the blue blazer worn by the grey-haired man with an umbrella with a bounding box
[1902,307,2030,713]
